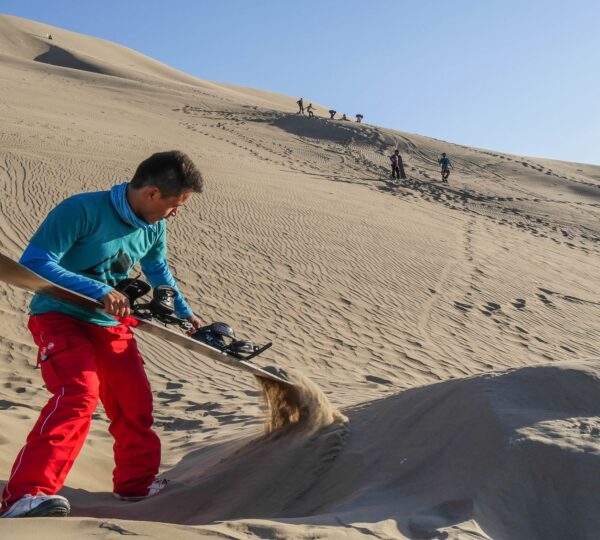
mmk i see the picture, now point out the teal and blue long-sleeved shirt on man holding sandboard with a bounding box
[19,183,192,326]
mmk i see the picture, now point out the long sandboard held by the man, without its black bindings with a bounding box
[0,253,291,386]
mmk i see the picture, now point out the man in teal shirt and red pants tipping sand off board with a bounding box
[1,151,203,518]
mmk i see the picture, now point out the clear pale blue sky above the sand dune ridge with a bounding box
[0,0,600,164]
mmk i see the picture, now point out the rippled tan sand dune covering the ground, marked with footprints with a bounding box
[0,16,600,540]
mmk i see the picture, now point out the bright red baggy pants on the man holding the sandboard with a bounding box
[2,312,160,509]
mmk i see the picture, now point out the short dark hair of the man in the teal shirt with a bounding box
[129,150,204,197]
